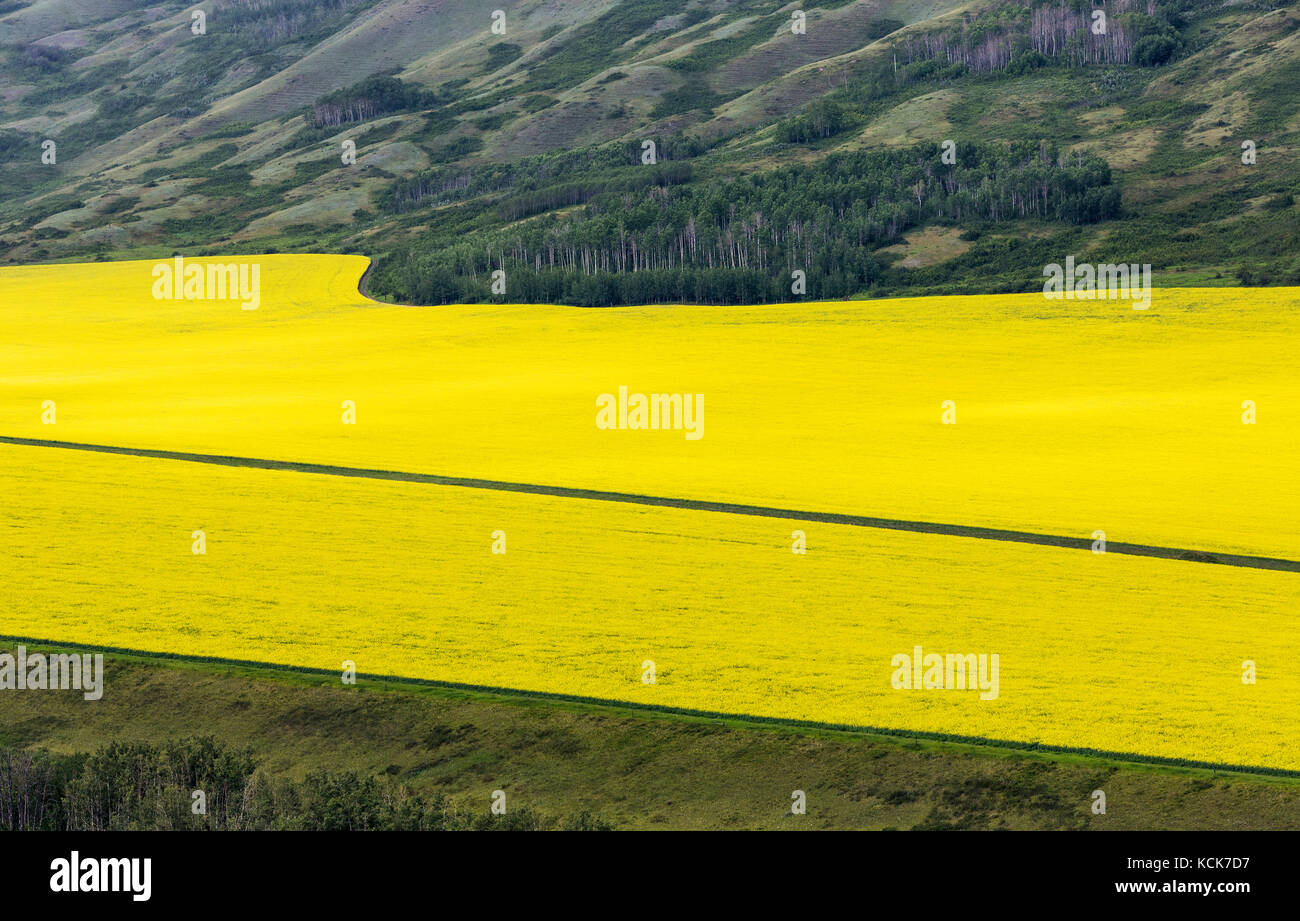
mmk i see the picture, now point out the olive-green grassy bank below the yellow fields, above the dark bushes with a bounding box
[0,645,1300,830]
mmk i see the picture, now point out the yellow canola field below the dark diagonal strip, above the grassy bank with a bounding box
[0,446,1300,769]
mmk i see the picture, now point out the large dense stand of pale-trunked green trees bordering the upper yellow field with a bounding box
[374,143,1119,304]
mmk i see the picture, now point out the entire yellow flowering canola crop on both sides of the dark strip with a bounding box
[0,256,1300,769]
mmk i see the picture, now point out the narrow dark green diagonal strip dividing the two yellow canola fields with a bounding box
[0,434,1300,572]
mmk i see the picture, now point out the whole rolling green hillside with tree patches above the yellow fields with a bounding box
[0,0,1300,306]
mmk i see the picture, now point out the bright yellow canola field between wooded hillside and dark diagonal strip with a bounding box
[0,255,1300,558]
